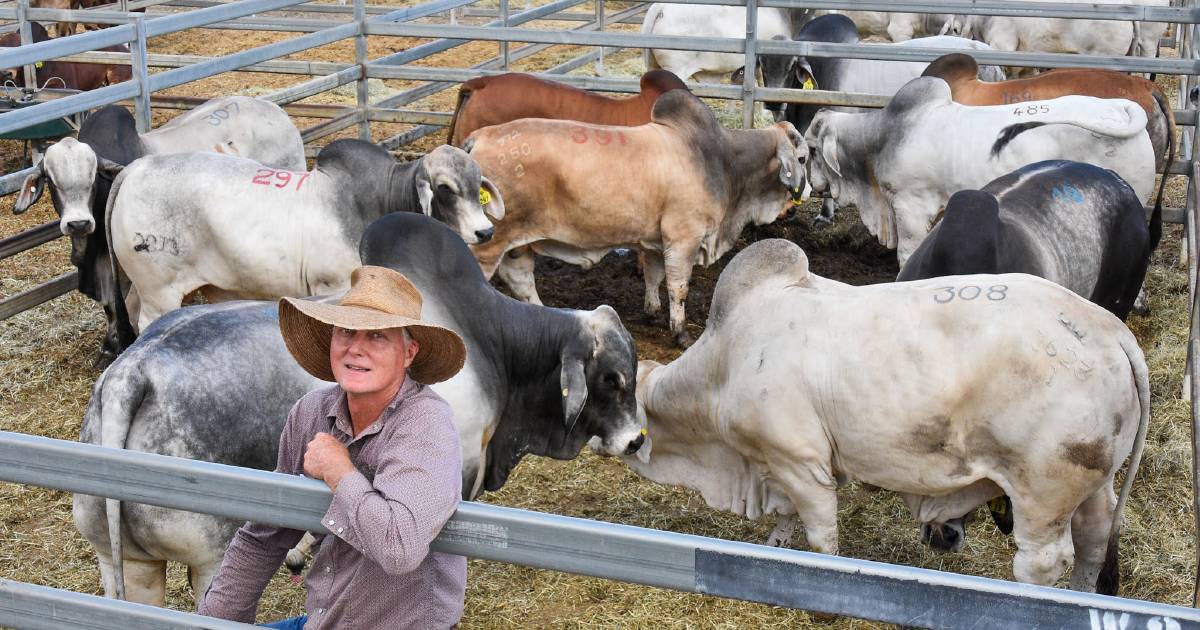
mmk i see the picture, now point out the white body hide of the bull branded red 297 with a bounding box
[109,154,359,330]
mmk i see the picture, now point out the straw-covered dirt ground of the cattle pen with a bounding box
[0,5,1195,629]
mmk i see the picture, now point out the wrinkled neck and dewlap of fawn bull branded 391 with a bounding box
[698,127,790,266]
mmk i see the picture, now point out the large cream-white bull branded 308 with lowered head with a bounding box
[625,239,1150,593]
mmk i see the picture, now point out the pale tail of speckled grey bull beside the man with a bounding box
[94,364,146,600]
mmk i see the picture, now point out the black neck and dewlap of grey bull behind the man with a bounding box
[478,304,594,491]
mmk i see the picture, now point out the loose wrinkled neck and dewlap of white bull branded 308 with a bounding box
[623,345,796,520]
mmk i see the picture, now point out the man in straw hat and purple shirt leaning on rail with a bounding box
[199,266,467,630]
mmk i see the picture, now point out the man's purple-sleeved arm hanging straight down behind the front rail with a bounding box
[197,398,304,623]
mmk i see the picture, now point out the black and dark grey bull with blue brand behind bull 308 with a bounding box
[896,161,1163,319]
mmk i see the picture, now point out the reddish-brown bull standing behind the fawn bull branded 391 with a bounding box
[446,70,688,146]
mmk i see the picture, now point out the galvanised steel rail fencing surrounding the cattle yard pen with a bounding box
[0,0,1200,630]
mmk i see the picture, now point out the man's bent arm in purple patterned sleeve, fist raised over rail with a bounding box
[322,400,462,575]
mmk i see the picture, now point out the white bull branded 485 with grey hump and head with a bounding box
[805,77,1154,266]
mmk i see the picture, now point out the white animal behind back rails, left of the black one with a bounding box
[642,4,792,83]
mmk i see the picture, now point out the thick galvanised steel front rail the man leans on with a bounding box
[0,432,1200,630]
